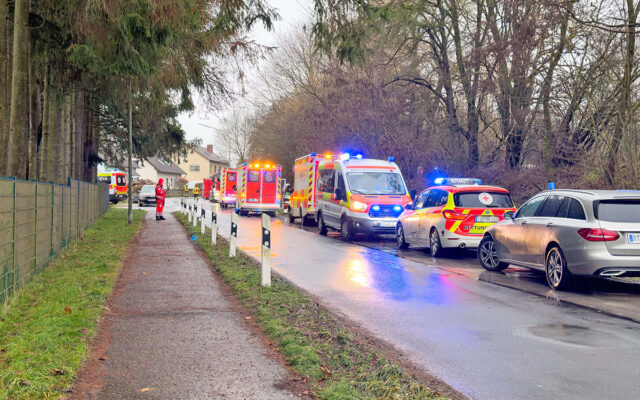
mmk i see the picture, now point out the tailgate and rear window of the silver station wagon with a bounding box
[594,198,640,256]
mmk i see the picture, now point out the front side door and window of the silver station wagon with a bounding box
[494,195,546,262]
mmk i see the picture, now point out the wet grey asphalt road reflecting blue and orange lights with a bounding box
[169,199,640,399]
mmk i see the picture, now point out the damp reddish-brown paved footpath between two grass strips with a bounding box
[73,212,296,400]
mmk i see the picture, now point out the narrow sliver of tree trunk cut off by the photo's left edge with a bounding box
[0,0,10,176]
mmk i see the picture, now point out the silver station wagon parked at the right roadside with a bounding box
[478,190,640,289]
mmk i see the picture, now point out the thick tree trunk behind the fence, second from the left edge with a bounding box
[8,0,29,179]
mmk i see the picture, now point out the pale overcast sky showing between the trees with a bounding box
[178,0,312,156]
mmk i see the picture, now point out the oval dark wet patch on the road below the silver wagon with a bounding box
[516,324,640,349]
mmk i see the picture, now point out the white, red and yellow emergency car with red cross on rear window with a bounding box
[396,178,515,257]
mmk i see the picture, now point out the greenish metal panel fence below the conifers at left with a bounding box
[0,178,109,304]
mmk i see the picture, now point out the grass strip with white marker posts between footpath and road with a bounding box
[175,213,445,400]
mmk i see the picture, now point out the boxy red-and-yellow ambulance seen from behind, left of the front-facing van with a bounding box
[236,163,282,217]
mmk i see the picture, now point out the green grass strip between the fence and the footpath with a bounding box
[0,209,144,399]
